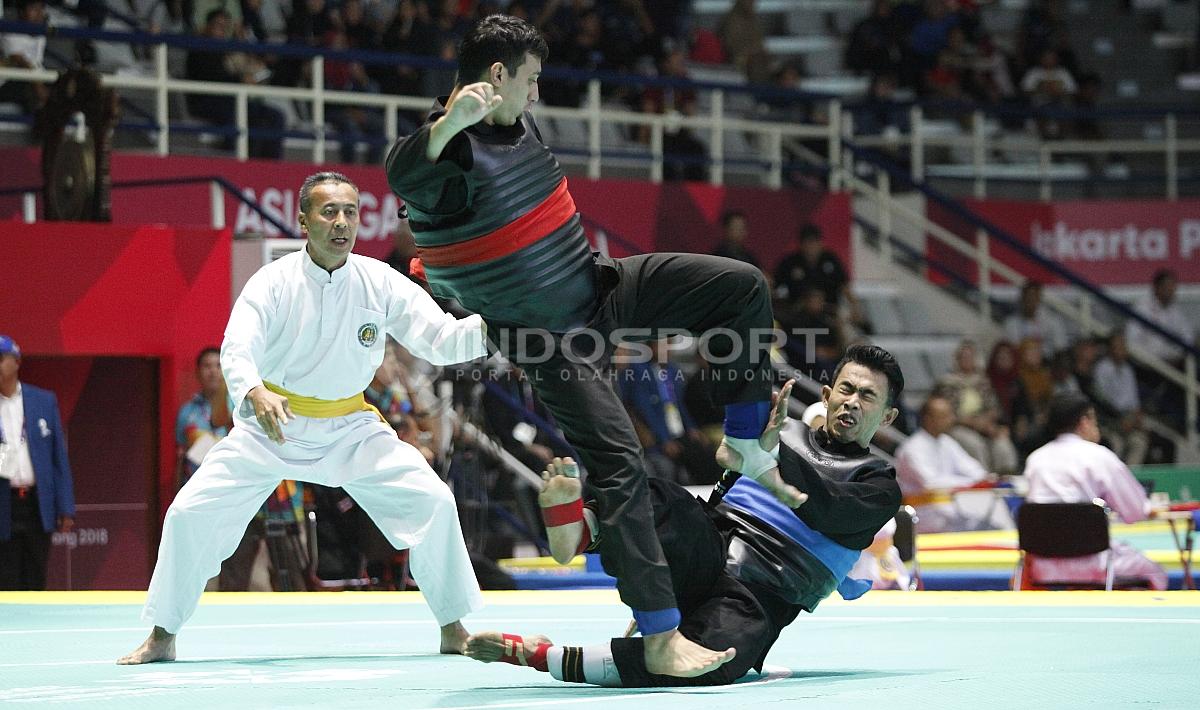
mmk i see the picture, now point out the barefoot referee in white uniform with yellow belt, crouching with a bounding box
[118,173,487,664]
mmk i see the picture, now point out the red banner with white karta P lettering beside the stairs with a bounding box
[929,199,1200,285]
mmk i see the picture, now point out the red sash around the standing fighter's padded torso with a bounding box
[416,178,576,266]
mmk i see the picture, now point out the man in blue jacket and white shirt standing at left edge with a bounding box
[0,336,74,590]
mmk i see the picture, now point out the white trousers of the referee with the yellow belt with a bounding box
[142,411,482,633]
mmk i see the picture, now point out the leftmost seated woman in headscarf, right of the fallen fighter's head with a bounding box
[935,341,1016,474]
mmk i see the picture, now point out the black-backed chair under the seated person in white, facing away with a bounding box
[1013,498,1114,591]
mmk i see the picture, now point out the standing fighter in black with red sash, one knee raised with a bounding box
[386,16,772,676]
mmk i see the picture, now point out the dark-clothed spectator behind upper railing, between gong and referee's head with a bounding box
[186,8,284,158]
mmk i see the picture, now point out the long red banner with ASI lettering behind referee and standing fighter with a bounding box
[0,149,852,269]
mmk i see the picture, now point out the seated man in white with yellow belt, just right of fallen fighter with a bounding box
[896,393,1004,533]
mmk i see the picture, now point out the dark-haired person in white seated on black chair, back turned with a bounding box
[1025,395,1166,590]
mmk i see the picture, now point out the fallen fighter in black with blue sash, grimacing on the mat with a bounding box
[467,345,904,687]
